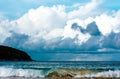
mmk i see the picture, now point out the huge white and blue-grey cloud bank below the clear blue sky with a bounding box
[0,0,120,60]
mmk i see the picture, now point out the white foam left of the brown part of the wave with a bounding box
[0,67,44,77]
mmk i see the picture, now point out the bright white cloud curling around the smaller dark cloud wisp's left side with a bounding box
[63,19,90,45]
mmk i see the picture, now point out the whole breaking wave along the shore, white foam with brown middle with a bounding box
[0,67,120,78]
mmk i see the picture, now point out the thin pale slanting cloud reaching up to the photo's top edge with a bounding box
[68,0,103,19]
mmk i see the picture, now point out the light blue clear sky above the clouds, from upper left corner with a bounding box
[0,0,90,20]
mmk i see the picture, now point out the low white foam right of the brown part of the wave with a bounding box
[75,70,120,78]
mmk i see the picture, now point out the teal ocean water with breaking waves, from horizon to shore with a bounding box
[0,61,120,79]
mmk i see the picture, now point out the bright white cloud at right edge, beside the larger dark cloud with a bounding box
[95,14,120,35]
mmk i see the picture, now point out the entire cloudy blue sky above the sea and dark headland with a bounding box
[0,0,120,61]
